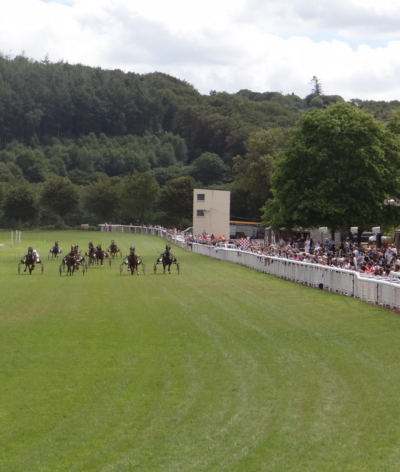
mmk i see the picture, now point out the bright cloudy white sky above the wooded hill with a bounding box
[0,0,400,101]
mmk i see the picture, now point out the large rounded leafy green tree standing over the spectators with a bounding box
[264,103,399,236]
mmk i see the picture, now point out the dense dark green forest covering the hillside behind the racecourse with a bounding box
[0,54,400,227]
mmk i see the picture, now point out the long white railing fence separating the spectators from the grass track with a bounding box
[100,225,400,308]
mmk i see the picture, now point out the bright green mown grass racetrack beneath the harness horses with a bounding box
[0,231,400,472]
